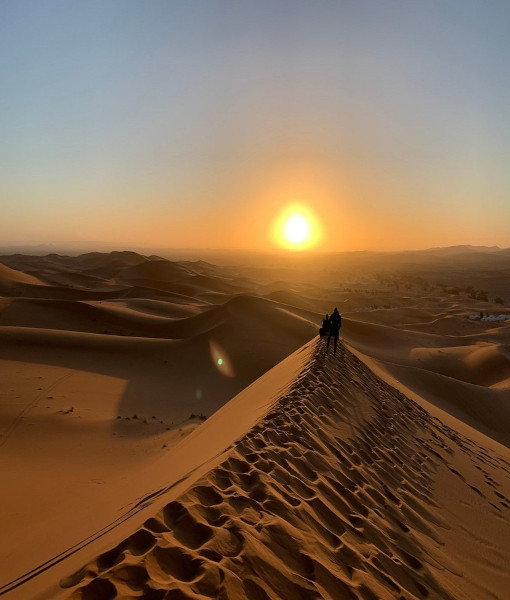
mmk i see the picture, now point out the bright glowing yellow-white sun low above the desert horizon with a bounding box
[273,206,320,250]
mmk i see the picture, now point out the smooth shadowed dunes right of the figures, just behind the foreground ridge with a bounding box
[342,318,510,446]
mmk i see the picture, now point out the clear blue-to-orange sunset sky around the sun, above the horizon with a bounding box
[0,0,510,251]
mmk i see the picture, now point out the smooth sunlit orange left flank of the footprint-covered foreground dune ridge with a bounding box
[0,340,313,598]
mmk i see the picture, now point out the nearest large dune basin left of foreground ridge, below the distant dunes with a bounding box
[0,290,315,596]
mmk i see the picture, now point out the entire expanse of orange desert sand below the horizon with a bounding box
[0,248,510,600]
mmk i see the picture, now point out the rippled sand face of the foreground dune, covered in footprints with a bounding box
[61,341,510,600]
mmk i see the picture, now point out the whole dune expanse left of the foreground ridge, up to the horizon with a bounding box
[0,252,316,597]
